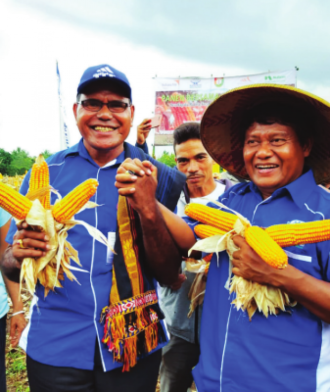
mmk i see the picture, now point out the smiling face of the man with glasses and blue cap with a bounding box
[73,90,134,154]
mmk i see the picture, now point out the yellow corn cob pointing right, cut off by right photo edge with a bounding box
[266,219,330,248]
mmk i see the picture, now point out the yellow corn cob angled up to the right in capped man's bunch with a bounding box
[53,178,99,223]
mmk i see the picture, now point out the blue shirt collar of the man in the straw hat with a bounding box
[240,169,317,208]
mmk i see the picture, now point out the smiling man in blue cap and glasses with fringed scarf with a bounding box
[3,64,185,392]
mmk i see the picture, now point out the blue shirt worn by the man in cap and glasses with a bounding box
[7,140,185,371]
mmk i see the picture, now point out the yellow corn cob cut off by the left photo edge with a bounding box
[0,182,32,219]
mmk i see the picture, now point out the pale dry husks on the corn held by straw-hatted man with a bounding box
[186,201,296,321]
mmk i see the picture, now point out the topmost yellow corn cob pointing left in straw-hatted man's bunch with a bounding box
[185,203,237,232]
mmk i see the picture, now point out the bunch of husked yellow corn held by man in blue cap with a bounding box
[0,156,98,296]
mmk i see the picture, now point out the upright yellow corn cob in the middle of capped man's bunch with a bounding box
[29,155,50,210]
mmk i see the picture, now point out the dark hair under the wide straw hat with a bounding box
[239,102,315,146]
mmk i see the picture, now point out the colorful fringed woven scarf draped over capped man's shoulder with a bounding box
[101,143,185,371]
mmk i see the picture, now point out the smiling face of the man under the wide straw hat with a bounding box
[243,122,311,198]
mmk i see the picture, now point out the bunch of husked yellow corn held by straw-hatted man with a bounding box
[185,203,330,320]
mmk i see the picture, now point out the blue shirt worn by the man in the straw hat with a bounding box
[186,171,330,392]
